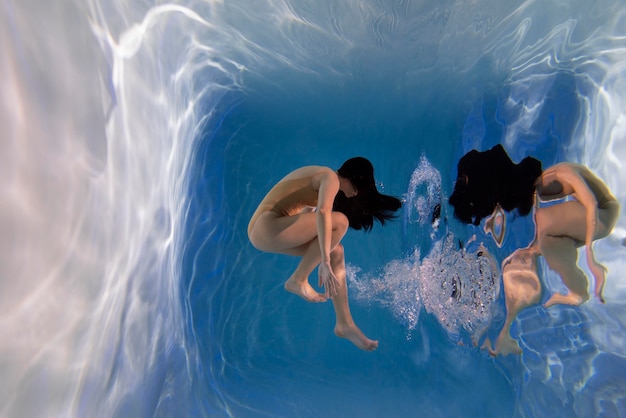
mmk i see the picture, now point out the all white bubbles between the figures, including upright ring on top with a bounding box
[347,156,500,342]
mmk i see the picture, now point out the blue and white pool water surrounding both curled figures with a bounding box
[0,0,626,417]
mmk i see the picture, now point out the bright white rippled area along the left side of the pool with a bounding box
[0,1,227,416]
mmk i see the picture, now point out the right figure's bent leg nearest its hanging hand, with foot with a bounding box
[539,236,589,307]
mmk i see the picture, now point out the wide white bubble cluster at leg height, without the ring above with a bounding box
[347,235,500,342]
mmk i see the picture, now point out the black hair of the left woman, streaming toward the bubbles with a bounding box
[333,157,402,231]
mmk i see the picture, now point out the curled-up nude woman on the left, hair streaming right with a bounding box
[248,157,402,351]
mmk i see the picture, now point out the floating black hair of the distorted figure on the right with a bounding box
[449,145,542,225]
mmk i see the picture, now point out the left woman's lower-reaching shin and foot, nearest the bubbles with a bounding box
[330,244,378,351]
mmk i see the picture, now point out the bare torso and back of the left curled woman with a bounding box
[248,166,330,233]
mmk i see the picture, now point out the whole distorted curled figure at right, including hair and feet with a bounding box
[449,145,620,356]
